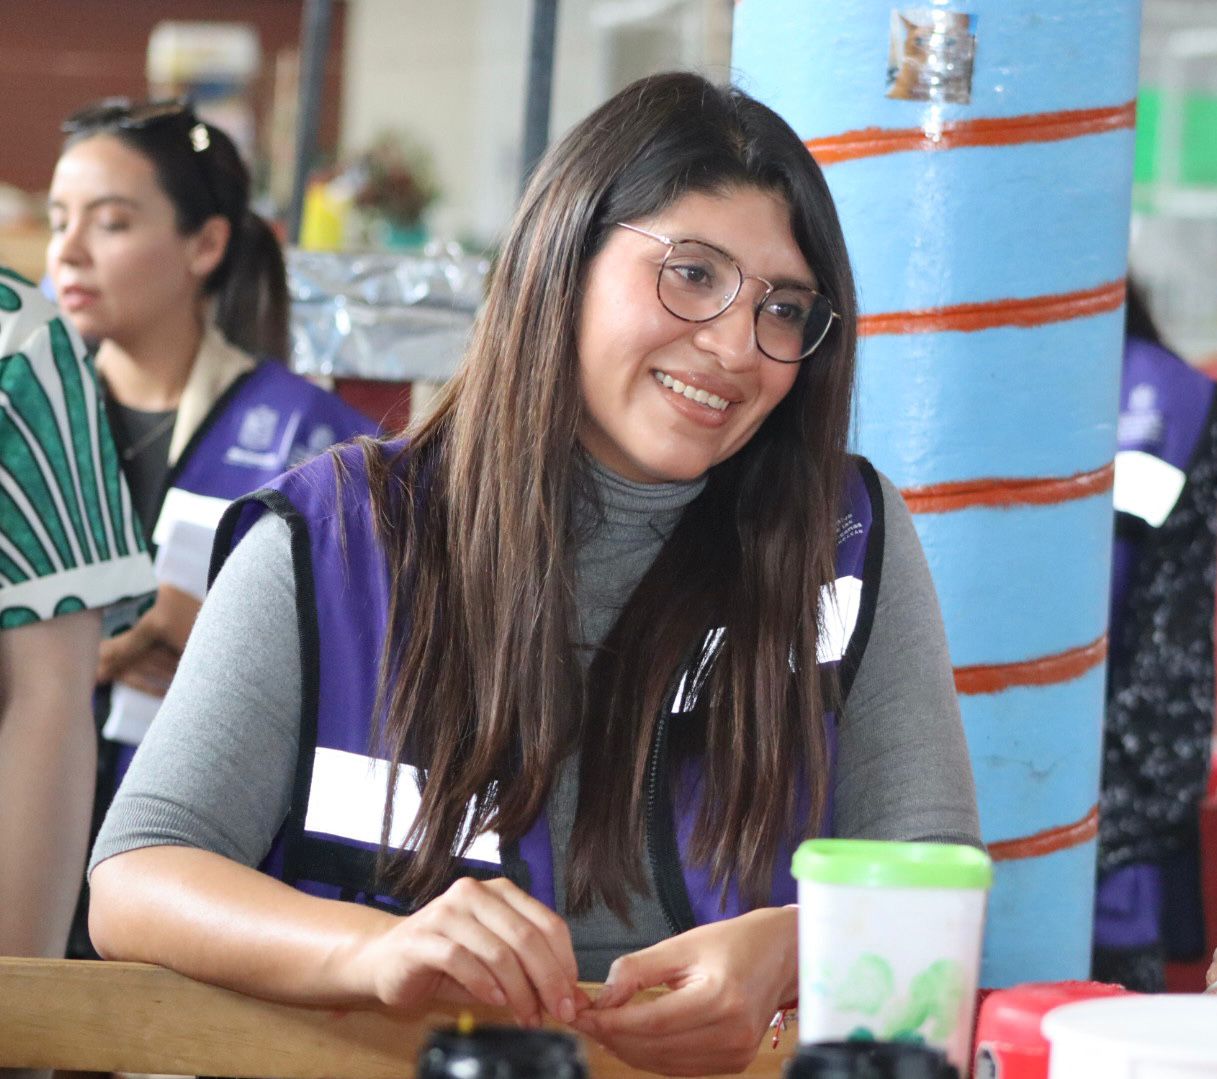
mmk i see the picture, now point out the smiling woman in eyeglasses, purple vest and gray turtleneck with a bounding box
[91,74,977,1074]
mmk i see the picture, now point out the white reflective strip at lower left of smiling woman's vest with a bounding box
[304,747,500,865]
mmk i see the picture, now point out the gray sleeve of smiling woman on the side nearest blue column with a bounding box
[835,476,981,845]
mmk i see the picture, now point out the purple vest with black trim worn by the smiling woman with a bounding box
[213,444,882,933]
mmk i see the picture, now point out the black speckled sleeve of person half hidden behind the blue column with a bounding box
[1099,406,1217,872]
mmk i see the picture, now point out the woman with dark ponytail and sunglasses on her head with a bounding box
[46,100,375,783]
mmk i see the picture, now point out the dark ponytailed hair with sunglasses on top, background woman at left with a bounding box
[62,97,288,363]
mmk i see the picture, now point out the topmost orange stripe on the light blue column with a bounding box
[806,101,1137,165]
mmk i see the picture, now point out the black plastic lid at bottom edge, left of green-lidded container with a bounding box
[417,1027,588,1079]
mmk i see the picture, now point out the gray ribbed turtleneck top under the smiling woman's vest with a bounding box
[90,470,980,979]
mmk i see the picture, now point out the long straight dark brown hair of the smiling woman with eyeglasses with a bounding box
[366,74,857,914]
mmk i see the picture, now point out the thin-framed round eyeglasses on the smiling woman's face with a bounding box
[616,221,841,364]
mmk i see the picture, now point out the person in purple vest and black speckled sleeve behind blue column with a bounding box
[1092,282,1217,993]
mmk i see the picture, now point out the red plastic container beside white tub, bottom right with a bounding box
[972,982,1129,1079]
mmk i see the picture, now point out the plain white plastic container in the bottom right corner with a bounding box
[1043,994,1217,1079]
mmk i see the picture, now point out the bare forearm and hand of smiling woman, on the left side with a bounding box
[89,845,590,1023]
